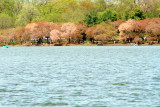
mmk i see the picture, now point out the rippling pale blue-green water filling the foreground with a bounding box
[0,46,160,107]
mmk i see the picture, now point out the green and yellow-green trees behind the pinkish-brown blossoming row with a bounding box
[0,0,160,27]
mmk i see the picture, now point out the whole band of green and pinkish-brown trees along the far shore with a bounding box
[0,0,160,44]
